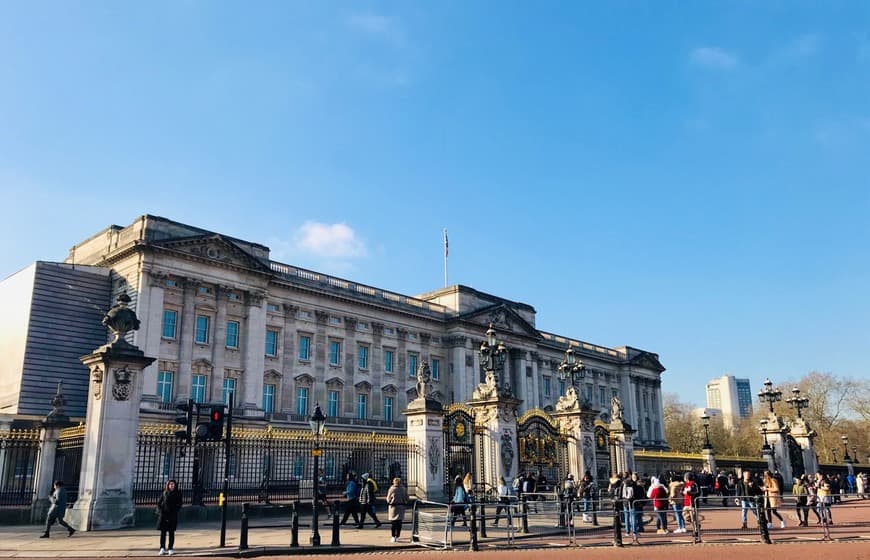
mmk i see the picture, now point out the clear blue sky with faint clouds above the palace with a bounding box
[0,1,870,404]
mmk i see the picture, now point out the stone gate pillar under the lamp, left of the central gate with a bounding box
[468,395,522,488]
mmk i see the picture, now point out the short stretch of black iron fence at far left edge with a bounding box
[0,430,39,506]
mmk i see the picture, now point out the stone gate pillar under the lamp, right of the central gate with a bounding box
[553,386,598,479]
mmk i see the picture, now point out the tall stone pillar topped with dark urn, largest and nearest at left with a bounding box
[69,294,154,531]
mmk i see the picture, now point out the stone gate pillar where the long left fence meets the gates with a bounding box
[402,397,447,502]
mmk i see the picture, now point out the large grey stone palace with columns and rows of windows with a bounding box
[0,215,667,448]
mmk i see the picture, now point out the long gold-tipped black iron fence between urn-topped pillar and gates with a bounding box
[133,424,419,505]
